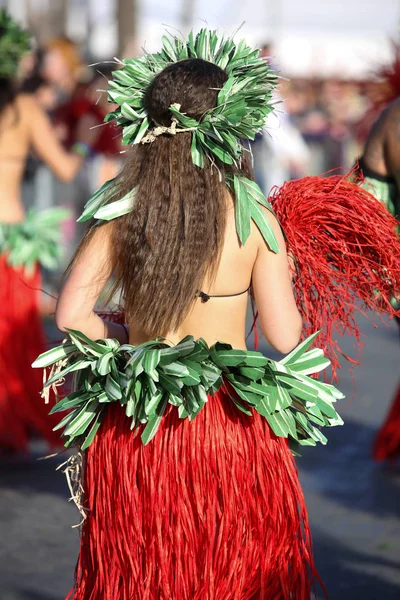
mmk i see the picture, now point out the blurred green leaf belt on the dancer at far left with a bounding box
[0,208,69,270]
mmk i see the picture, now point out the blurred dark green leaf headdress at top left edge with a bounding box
[0,8,31,78]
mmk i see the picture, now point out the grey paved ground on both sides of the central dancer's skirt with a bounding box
[0,312,400,600]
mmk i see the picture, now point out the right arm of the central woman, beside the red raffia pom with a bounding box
[252,209,302,353]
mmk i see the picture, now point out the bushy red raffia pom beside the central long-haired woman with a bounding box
[269,170,400,380]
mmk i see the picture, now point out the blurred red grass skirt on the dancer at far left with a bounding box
[0,255,59,452]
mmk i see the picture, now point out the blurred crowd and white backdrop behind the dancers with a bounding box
[5,0,400,274]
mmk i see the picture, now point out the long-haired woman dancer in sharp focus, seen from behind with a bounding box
[34,30,400,600]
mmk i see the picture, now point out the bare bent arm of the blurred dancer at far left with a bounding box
[23,96,82,181]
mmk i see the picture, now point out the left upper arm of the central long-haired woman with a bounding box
[56,223,113,329]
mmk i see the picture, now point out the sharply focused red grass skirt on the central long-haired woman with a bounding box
[68,391,316,600]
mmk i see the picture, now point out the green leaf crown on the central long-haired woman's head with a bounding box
[107,29,277,167]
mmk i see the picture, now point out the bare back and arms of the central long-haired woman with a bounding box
[56,193,302,353]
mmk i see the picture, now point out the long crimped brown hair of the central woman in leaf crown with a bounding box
[78,59,250,337]
